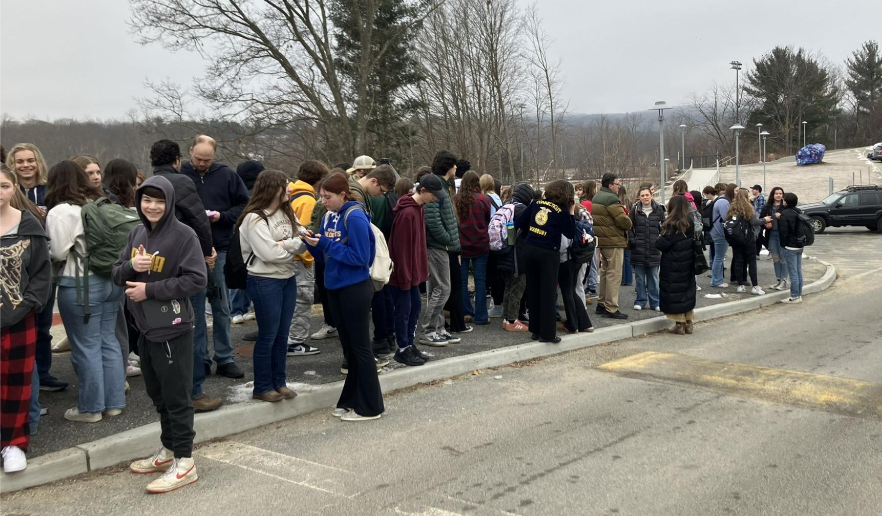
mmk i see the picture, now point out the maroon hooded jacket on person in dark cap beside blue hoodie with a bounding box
[389,195,429,290]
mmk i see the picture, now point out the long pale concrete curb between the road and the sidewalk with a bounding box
[0,260,836,493]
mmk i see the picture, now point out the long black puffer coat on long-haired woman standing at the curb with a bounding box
[655,224,695,314]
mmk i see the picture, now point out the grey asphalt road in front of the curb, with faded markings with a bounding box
[2,231,882,516]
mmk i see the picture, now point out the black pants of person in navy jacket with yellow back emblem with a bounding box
[525,245,560,340]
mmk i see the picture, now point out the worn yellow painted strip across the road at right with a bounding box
[599,351,882,417]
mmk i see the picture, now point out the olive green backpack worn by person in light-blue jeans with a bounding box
[71,197,141,322]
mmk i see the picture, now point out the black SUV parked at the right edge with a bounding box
[799,185,882,233]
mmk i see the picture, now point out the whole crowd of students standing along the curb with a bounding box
[0,140,802,493]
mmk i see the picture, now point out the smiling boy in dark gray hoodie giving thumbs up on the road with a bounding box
[113,176,208,493]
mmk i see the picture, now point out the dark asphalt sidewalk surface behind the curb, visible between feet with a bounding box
[28,247,824,457]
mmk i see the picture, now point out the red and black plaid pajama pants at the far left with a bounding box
[0,312,37,449]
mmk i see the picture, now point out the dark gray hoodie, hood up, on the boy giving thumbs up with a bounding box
[113,176,208,342]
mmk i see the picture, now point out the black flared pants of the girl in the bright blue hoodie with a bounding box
[328,279,385,416]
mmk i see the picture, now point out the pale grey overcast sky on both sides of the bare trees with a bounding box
[0,0,882,119]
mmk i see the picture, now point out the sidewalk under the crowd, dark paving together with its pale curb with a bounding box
[0,257,835,492]
